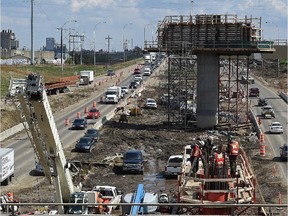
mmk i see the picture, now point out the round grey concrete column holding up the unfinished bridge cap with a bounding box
[196,54,220,129]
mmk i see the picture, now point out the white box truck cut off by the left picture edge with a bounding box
[0,148,14,185]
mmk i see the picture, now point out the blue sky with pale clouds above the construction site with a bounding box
[1,0,287,51]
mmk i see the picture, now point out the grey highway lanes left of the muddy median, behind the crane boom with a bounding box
[1,61,162,190]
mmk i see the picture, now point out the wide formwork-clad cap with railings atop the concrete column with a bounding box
[144,14,275,55]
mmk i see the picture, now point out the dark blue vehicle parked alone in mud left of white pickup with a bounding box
[123,150,144,174]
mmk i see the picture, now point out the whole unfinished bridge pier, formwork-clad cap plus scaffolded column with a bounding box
[144,14,275,129]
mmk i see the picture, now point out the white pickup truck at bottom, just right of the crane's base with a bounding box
[92,186,122,214]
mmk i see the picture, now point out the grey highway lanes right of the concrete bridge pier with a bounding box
[250,80,288,185]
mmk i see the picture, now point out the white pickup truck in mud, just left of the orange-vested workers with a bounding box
[165,155,183,179]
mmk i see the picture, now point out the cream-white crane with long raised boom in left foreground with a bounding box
[9,74,97,214]
